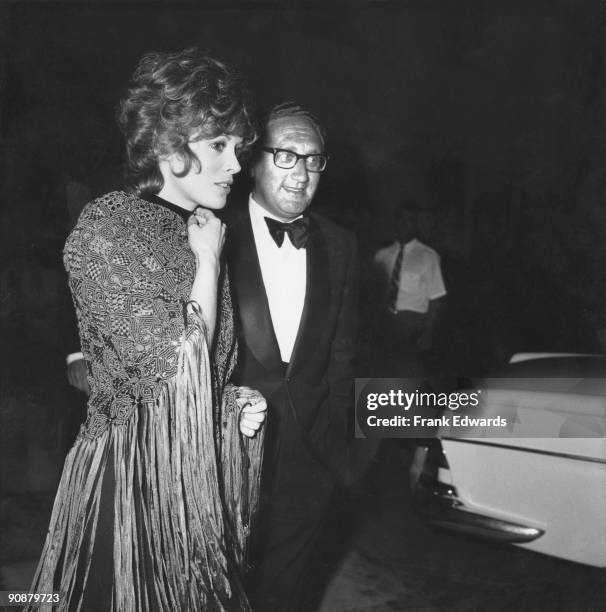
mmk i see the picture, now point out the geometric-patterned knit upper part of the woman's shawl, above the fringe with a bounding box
[64,198,200,401]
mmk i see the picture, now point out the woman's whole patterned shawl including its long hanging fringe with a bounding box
[27,192,263,612]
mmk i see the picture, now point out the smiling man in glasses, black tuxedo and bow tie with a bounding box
[226,104,357,612]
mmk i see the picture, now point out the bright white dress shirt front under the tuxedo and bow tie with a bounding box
[248,195,307,362]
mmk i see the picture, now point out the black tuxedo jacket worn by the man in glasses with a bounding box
[226,206,357,484]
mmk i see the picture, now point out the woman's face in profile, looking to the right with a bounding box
[158,134,242,210]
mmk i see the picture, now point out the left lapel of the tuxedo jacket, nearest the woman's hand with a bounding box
[228,210,282,372]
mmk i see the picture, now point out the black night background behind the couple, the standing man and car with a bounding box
[0,0,606,610]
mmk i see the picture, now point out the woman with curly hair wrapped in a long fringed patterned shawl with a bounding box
[32,49,266,612]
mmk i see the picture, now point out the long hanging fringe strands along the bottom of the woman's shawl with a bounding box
[27,314,262,612]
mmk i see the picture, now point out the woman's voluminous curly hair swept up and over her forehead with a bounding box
[118,47,257,195]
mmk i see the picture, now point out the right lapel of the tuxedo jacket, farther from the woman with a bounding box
[286,217,330,376]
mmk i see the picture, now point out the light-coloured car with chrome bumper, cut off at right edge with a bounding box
[411,354,606,567]
